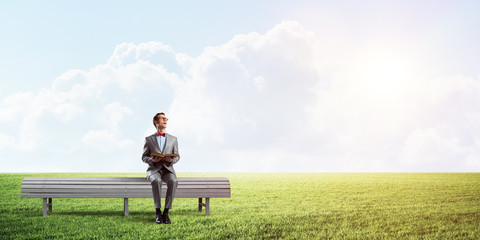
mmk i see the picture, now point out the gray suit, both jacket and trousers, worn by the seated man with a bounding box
[142,133,180,209]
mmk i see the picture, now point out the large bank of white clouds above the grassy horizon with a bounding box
[0,21,480,172]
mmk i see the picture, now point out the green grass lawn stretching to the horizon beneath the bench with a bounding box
[0,173,480,239]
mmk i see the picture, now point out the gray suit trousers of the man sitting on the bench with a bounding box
[148,168,177,209]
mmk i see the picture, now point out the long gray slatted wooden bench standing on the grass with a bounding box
[21,177,230,217]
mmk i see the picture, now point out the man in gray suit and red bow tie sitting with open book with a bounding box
[142,113,180,224]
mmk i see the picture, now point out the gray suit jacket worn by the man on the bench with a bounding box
[142,133,180,176]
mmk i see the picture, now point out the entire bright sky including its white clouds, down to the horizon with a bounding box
[0,1,480,172]
